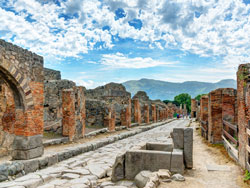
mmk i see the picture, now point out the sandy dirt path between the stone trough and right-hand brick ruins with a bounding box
[159,123,250,188]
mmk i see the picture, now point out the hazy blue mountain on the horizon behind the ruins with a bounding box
[122,78,237,100]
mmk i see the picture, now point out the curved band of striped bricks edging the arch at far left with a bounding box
[0,59,34,109]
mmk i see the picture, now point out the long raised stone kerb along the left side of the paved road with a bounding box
[0,119,175,183]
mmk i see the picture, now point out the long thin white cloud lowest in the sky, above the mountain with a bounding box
[101,53,178,69]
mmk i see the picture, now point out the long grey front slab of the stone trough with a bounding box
[125,150,171,180]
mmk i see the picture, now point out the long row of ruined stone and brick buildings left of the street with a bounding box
[0,40,180,162]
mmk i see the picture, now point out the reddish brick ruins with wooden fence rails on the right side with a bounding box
[199,64,250,171]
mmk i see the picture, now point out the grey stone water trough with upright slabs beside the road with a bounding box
[112,128,193,181]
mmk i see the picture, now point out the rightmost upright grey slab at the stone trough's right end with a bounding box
[184,128,193,168]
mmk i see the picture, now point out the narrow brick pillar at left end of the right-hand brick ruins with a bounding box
[200,95,208,139]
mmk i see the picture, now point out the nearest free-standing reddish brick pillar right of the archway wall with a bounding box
[62,89,76,141]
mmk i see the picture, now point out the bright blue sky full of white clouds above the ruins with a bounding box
[0,0,250,88]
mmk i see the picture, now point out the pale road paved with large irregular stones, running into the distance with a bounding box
[0,120,189,188]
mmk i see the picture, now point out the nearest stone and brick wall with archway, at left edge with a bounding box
[0,40,44,159]
